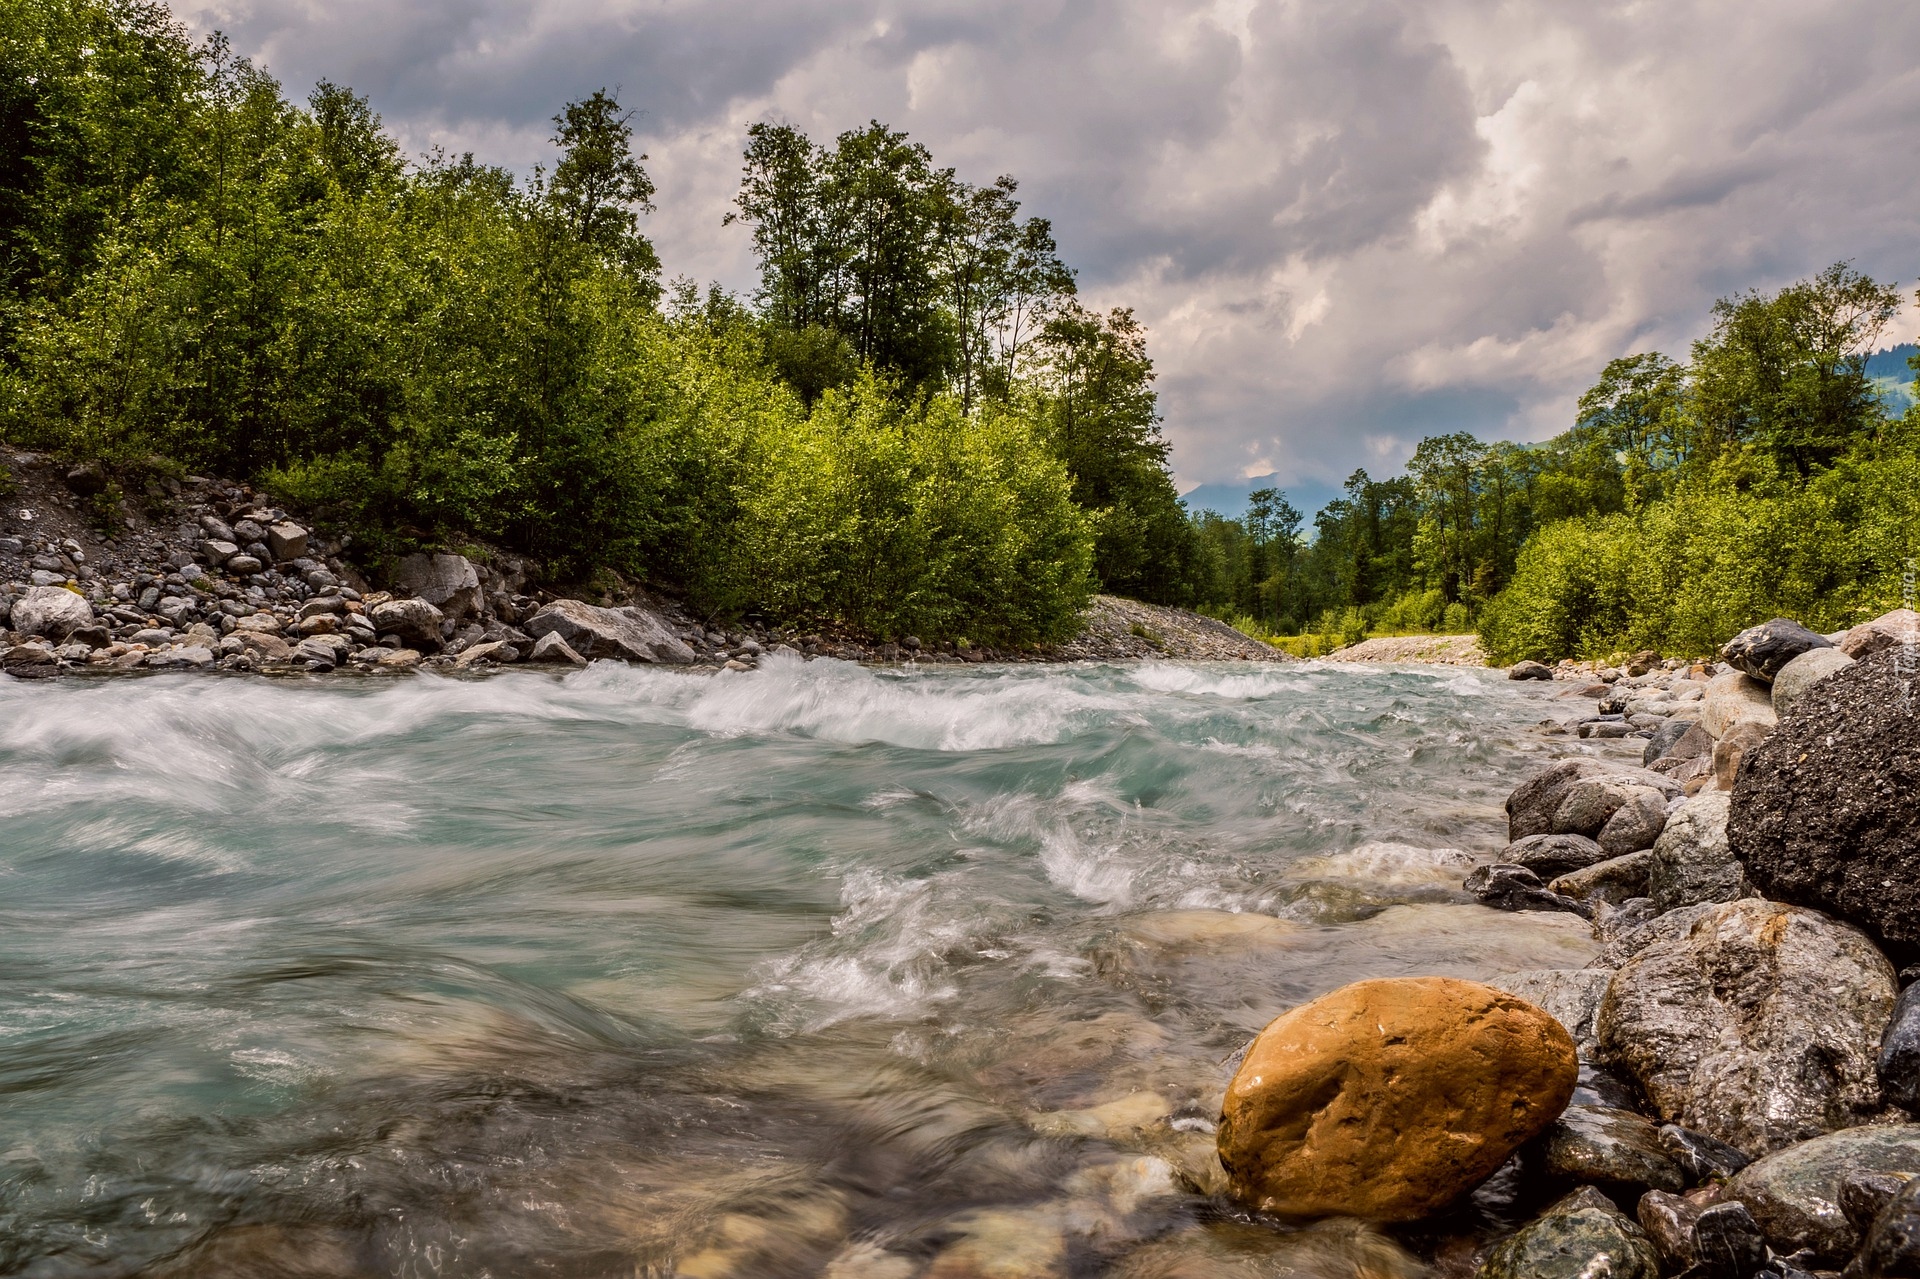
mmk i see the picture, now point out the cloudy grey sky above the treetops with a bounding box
[161,0,1920,509]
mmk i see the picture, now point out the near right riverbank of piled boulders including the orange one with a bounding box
[1219,611,1920,1279]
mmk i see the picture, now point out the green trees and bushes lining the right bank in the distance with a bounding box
[1198,263,1920,661]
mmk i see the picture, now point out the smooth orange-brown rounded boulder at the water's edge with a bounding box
[1217,977,1578,1221]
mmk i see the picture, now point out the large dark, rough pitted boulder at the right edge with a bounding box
[1726,647,1920,962]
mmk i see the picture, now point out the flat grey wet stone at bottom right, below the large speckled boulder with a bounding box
[1728,1123,1920,1266]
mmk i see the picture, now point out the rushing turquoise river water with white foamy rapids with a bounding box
[0,659,1592,1279]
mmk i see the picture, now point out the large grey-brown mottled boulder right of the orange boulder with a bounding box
[1596,899,1893,1156]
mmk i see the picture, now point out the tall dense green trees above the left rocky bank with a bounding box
[0,0,1196,643]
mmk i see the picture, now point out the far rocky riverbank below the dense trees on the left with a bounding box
[0,453,1286,678]
